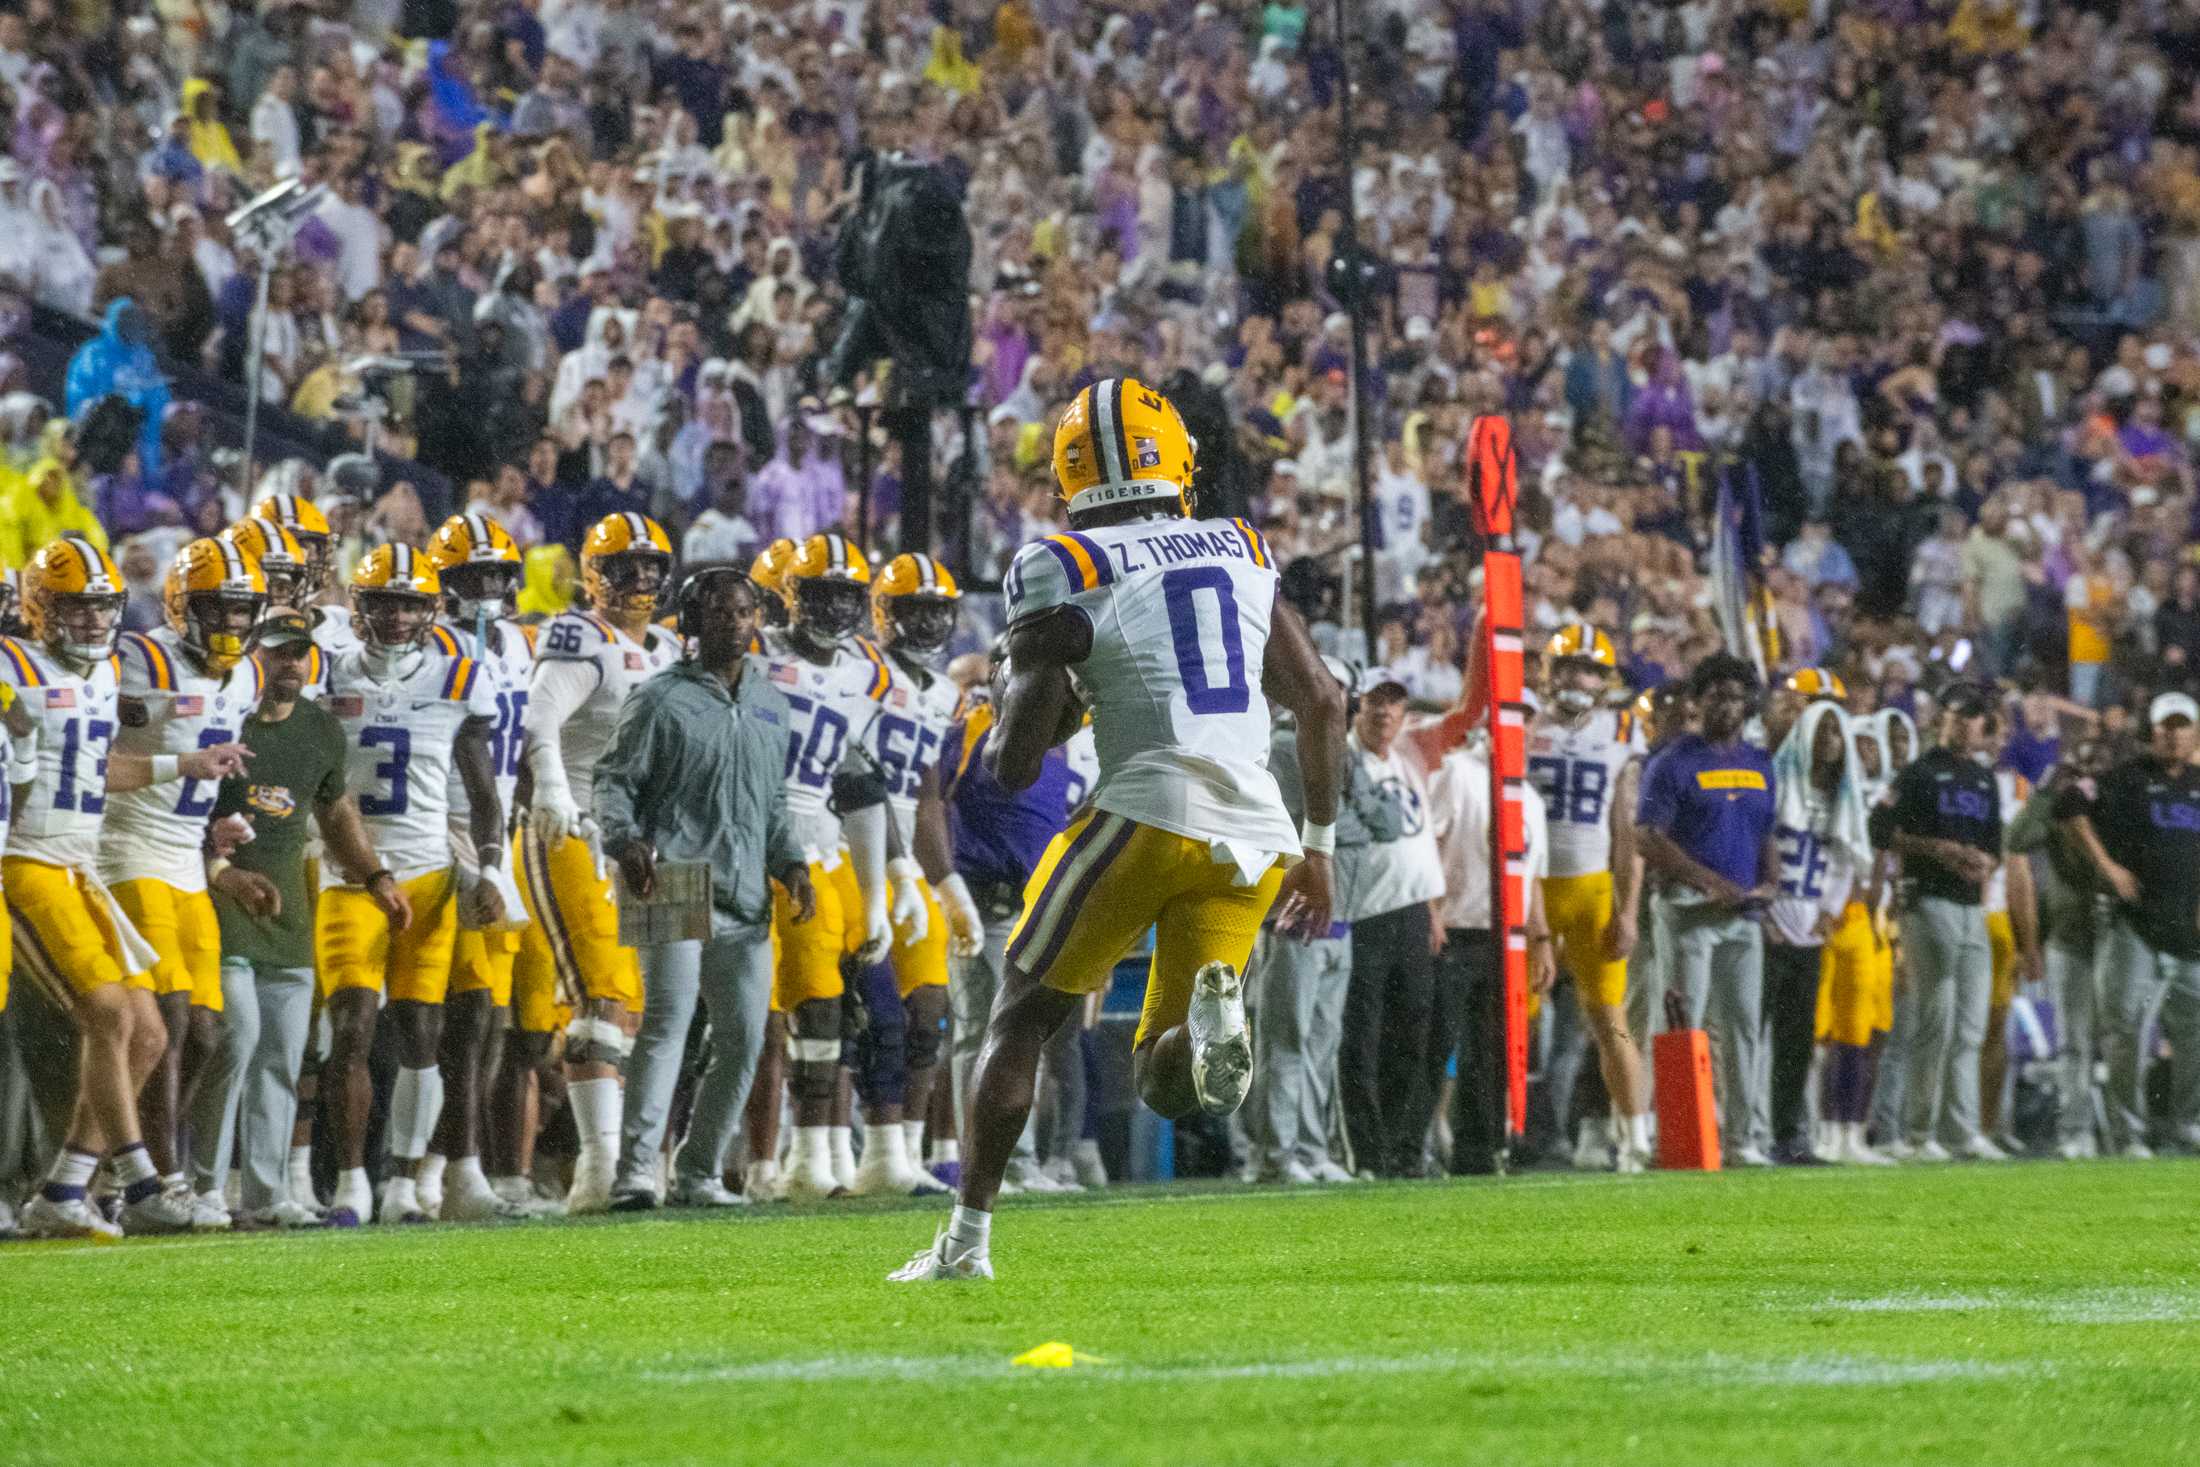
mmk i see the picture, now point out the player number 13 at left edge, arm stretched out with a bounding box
[0,539,244,1238]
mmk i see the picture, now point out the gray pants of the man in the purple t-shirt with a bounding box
[1650,895,1773,1157]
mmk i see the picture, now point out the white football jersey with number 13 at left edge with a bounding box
[0,638,119,871]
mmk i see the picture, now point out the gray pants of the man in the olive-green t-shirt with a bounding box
[191,957,312,1212]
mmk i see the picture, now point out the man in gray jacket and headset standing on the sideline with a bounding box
[594,565,816,1212]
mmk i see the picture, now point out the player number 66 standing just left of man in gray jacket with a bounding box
[512,512,680,1212]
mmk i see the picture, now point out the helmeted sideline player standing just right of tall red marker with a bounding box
[1527,622,1650,1172]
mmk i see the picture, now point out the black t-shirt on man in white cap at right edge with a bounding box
[2055,754,2200,957]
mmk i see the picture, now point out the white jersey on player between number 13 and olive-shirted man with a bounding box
[99,627,260,891]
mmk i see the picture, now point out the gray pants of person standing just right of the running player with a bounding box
[1245,928,1353,1170]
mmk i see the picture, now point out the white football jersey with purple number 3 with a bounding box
[321,638,497,886]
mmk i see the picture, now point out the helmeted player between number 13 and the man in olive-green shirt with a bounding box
[99,539,268,1229]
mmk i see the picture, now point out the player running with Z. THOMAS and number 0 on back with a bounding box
[891,378,1344,1282]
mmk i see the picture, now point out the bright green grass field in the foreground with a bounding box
[0,1161,2200,1467]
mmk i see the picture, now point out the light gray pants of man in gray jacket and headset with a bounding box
[616,924,772,1194]
